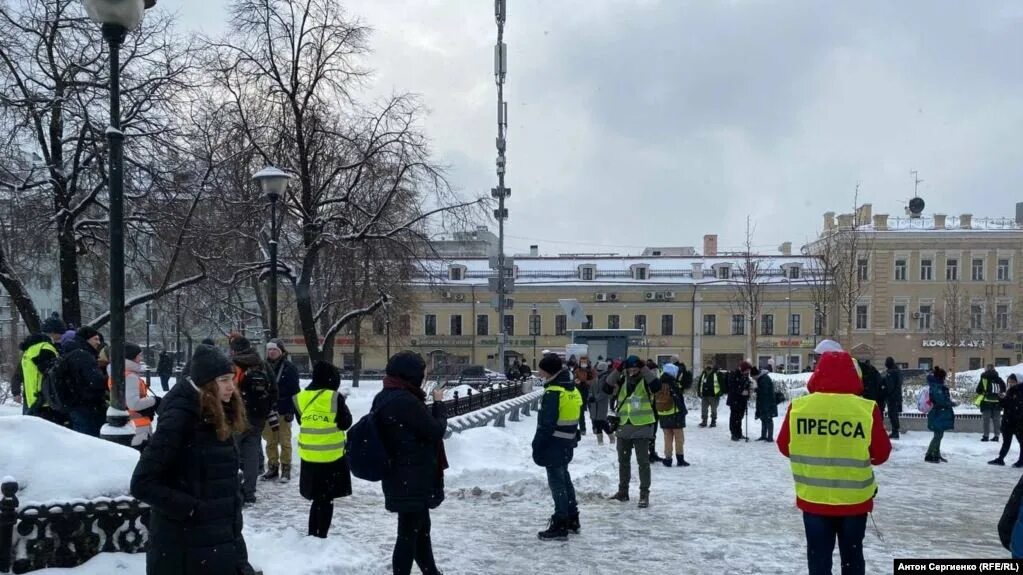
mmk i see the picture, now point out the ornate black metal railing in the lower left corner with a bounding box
[0,481,149,573]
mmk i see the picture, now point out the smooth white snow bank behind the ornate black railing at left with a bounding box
[0,415,138,505]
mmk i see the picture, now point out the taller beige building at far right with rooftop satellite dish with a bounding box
[807,203,1023,370]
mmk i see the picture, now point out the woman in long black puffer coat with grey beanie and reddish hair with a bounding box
[131,346,253,575]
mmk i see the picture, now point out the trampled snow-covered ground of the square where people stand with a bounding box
[6,383,1020,575]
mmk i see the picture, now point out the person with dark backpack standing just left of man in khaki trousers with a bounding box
[230,334,280,504]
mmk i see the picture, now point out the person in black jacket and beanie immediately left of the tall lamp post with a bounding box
[61,325,107,437]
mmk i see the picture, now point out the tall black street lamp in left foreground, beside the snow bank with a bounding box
[84,0,157,445]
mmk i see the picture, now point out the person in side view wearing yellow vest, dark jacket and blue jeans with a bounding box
[532,353,582,541]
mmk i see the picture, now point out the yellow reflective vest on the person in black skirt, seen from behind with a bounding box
[295,390,346,463]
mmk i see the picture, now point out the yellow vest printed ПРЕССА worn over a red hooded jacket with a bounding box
[789,393,877,505]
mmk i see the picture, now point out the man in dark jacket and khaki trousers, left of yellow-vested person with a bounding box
[263,340,300,483]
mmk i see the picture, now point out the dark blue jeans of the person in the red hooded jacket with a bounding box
[803,512,866,575]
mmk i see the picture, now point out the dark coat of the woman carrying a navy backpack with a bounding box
[372,381,447,513]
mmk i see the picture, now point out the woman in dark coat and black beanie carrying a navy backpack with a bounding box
[372,351,447,575]
